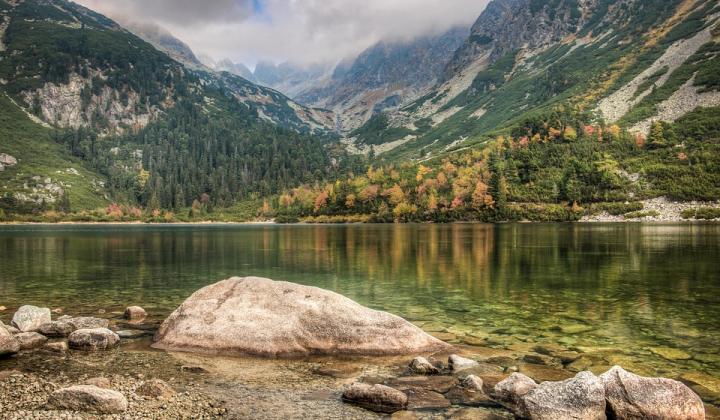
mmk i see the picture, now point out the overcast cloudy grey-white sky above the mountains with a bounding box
[75,0,488,67]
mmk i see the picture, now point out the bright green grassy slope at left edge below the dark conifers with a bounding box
[0,94,108,210]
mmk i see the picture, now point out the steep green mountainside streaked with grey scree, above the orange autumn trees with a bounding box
[354,0,720,159]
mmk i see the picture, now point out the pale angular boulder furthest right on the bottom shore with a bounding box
[600,366,705,420]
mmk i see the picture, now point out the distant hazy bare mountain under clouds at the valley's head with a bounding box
[294,28,468,131]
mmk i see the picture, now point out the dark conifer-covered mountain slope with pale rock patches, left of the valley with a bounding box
[0,0,341,217]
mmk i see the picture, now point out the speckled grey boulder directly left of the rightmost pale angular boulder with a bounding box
[516,371,606,420]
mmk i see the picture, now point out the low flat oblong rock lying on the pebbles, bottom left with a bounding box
[47,385,128,414]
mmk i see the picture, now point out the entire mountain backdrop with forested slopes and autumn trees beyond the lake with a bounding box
[0,0,720,222]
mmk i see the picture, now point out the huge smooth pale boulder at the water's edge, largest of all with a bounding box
[153,277,449,356]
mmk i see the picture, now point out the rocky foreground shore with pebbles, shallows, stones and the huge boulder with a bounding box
[0,278,720,419]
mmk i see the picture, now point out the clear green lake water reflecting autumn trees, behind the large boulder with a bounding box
[0,224,720,384]
